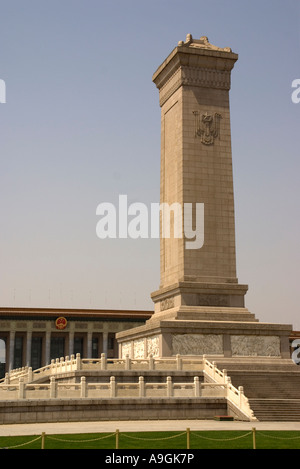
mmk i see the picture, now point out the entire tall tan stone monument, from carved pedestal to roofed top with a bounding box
[117,34,292,358]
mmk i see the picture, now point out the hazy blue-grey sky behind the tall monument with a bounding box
[0,0,300,330]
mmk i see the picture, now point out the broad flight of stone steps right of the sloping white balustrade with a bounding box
[213,358,300,422]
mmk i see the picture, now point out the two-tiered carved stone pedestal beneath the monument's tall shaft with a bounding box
[116,281,292,358]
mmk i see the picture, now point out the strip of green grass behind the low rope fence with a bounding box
[0,431,300,450]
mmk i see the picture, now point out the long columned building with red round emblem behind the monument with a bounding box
[0,308,152,377]
